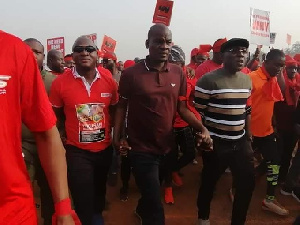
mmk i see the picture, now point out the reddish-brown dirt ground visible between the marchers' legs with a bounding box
[35,158,300,225]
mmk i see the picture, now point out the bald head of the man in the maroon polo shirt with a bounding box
[146,24,172,63]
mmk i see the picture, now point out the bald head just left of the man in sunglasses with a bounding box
[47,49,64,73]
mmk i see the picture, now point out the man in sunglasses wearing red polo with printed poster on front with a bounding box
[50,36,118,225]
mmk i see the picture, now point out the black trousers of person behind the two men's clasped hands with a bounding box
[174,127,195,171]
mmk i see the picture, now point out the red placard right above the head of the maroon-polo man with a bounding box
[152,0,173,26]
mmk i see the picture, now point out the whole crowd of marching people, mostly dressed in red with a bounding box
[0,24,300,225]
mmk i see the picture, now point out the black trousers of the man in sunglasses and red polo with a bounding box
[66,145,113,225]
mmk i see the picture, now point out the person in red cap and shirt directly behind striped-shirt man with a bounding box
[196,38,227,79]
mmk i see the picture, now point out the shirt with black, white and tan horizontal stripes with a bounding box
[195,68,252,140]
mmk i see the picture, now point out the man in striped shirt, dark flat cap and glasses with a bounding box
[195,38,254,225]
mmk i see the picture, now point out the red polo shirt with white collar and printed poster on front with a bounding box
[50,67,119,152]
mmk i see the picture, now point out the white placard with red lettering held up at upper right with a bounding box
[250,8,270,46]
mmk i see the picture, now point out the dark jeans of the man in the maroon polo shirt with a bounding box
[129,151,165,225]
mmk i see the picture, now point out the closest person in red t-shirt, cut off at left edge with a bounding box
[0,31,74,225]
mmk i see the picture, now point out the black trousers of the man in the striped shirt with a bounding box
[197,137,254,225]
